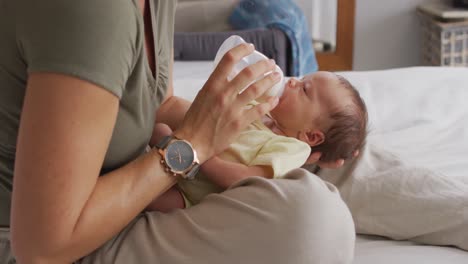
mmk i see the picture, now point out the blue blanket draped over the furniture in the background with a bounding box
[229,0,318,76]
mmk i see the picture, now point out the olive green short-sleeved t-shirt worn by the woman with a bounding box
[0,0,176,226]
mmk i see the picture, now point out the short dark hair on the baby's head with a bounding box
[312,75,368,162]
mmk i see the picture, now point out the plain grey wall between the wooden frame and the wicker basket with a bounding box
[353,0,431,70]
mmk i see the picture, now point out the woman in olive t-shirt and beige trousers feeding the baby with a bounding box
[0,0,354,263]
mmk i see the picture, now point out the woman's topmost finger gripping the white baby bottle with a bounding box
[210,43,255,82]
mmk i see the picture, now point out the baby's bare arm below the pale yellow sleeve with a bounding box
[201,157,273,189]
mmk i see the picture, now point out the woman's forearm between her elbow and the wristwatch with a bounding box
[68,150,176,262]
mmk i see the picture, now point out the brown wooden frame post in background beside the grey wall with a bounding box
[317,0,356,71]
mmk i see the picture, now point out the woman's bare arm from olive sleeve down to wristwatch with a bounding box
[11,73,179,263]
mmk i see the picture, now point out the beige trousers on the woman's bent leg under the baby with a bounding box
[0,169,355,264]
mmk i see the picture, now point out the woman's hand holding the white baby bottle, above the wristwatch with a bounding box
[174,44,280,163]
